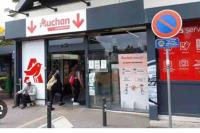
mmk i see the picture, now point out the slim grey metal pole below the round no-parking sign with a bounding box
[166,48,172,128]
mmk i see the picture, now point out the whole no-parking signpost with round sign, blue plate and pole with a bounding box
[151,10,182,128]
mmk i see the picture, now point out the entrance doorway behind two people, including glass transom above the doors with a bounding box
[48,38,86,105]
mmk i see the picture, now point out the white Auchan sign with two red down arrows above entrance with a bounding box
[26,10,87,37]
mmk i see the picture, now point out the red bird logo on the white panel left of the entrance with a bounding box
[24,58,43,83]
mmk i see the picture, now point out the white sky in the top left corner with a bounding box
[0,0,16,26]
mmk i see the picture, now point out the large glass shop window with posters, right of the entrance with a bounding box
[88,32,148,111]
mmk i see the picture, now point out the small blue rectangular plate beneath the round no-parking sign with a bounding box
[155,38,180,48]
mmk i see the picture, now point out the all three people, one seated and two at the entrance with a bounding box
[13,64,84,110]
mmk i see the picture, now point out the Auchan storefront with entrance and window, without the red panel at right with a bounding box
[7,1,149,112]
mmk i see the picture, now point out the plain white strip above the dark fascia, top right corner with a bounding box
[144,0,200,9]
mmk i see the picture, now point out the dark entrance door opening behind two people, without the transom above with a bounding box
[51,51,86,105]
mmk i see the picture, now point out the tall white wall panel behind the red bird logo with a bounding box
[22,40,45,104]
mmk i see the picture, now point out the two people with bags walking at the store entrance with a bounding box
[47,64,84,110]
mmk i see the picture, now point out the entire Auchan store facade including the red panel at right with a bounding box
[6,0,200,116]
